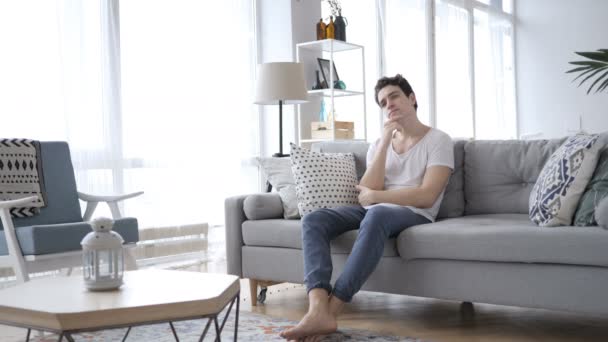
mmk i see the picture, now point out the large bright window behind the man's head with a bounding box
[322,0,517,140]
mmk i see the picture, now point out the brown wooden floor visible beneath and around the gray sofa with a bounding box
[0,224,608,342]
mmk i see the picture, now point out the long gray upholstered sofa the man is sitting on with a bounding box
[225,134,608,315]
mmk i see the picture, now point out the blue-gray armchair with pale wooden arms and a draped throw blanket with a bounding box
[0,142,143,282]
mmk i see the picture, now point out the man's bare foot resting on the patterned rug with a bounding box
[279,310,338,340]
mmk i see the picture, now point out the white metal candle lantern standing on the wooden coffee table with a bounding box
[80,217,124,291]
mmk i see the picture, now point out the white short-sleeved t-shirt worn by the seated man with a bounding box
[365,128,454,221]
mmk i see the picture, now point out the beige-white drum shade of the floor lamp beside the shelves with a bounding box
[254,62,308,105]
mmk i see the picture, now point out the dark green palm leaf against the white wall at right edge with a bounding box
[566,49,608,94]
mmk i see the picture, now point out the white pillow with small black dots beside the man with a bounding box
[291,144,359,216]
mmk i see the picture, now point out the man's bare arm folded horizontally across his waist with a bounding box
[359,166,452,208]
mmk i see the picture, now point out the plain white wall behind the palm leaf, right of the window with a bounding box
[515,0,608,138]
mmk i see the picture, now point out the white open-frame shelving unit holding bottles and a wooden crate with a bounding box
[296,39,367,144]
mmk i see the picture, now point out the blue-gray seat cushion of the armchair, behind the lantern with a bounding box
[0,217,139,255]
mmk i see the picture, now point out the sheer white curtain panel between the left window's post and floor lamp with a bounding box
[120,0,258,225]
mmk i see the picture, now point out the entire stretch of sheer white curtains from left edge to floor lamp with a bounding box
[0,0,258,228]
